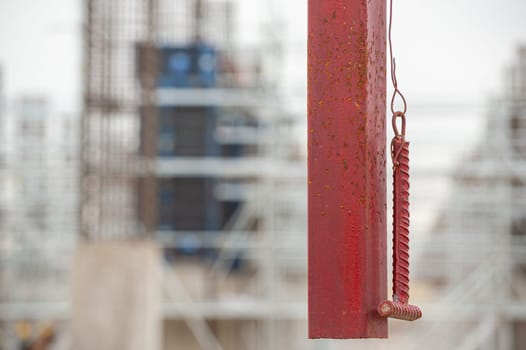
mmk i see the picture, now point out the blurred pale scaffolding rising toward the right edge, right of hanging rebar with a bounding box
[386,48,526,350]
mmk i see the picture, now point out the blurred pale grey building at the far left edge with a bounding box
[0,95,79,349]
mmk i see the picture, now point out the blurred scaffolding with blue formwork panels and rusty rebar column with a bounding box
[81,0,306,349]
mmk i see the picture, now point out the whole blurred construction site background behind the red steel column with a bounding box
[0,0,526,350]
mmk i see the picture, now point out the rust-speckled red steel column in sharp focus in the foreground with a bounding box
[308,0,387,338]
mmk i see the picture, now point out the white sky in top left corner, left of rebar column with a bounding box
[0,0,81,112]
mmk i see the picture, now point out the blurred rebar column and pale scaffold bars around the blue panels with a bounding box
[80,0,305,350]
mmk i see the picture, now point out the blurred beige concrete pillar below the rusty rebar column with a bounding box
[73,241,162,350]
